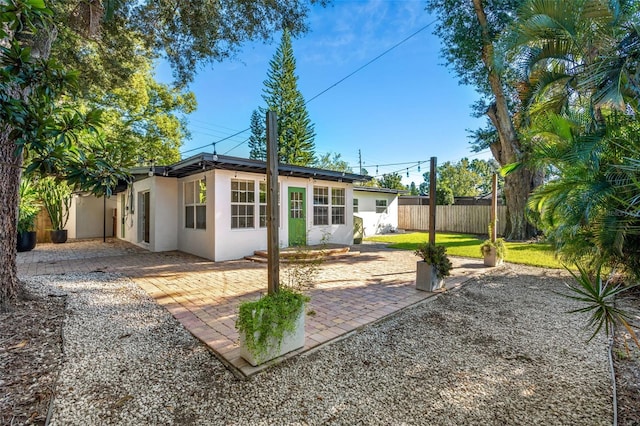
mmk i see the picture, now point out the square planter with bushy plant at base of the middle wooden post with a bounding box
[414,243,453,291]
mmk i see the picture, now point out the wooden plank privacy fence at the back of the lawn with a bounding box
[398,205,507,235]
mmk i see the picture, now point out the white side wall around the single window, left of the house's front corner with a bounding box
[178,172,217,260]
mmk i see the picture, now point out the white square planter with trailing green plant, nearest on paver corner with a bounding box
[236,288,309,366]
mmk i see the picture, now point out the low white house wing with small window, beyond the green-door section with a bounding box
[353,186,402,237]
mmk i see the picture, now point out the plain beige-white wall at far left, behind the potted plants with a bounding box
[66,194,116,239]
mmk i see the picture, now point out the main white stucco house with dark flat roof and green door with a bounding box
[116,153,370,261]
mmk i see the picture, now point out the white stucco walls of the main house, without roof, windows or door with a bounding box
[114,170,358,261]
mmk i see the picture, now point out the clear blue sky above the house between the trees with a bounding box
[157,0,489,184]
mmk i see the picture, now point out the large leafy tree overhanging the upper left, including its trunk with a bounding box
[0,0,320,307]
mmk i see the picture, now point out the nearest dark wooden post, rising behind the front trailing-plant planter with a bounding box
[267,111,280,294]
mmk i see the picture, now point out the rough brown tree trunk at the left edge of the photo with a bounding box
[0,123,22,310]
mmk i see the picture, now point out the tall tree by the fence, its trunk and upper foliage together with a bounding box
[428,0,542,240]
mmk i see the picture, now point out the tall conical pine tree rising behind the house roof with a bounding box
[249,30,315,166]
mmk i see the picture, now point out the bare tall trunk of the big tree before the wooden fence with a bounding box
[473,0,542,240]
